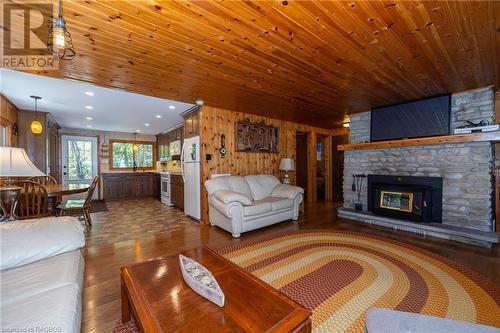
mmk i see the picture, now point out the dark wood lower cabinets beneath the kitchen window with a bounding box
[102,172,160,200]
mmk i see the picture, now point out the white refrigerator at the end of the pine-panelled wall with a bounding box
[181,136,201,221]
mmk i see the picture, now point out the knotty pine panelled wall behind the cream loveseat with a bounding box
[200,106,346,222]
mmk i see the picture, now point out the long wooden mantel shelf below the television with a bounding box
[337,131,500,151]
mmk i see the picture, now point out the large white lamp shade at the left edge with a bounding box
[0,147,45,177]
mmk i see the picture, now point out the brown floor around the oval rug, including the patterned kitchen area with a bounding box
[82,199,500,332]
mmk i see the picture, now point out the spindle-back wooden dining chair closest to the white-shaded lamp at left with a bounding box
[15,180,50,220]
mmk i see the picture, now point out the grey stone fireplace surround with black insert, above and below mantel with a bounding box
[339,88,494,244]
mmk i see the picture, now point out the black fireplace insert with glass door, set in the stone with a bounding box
[368,175,443,223]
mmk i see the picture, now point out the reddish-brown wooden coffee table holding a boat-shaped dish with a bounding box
[121,247,311,333]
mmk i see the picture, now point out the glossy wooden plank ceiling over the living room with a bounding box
[12,0,500,128]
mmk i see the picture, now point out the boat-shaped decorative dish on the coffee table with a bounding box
[179,254,225,307]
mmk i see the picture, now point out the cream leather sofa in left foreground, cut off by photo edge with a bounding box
[0,216,85,333]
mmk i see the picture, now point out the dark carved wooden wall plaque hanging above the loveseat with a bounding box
[236,118,279,153]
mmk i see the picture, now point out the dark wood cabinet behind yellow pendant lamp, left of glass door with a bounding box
[17,110,61,181]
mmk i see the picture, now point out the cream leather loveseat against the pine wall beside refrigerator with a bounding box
[205,175,304,237]
